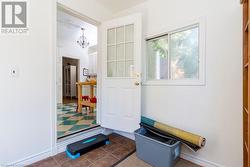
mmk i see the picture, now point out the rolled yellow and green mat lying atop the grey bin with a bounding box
[141,117,206,147]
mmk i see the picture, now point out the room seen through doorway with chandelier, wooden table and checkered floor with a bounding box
[56,7,98,139]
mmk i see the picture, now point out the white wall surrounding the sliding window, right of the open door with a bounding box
[113,0,242,167]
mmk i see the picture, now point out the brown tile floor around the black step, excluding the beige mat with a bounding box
[29,134,135,167]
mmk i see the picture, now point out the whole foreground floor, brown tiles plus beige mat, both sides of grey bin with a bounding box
[27,134,200,167]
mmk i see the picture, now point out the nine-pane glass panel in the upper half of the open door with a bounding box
[107,24,134,77]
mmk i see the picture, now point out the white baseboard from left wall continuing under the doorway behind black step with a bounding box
[7,127,103,166]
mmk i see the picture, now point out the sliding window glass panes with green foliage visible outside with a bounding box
[146,25,199,80]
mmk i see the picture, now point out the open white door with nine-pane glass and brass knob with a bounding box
[101,14,142,133]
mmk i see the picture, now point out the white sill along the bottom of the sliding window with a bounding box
[142,80,205,86]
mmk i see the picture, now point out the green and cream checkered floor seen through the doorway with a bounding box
[57,103,97,138]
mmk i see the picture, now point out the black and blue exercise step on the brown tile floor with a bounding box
[66,134,109,159]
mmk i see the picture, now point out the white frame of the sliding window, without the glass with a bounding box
[142,19,206,86]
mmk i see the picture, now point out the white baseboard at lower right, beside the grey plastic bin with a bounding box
[180,152,223,167]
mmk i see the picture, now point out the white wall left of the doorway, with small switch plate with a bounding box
[0,0,52,166]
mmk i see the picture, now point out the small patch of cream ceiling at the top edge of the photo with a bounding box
[96,0,147,12]
